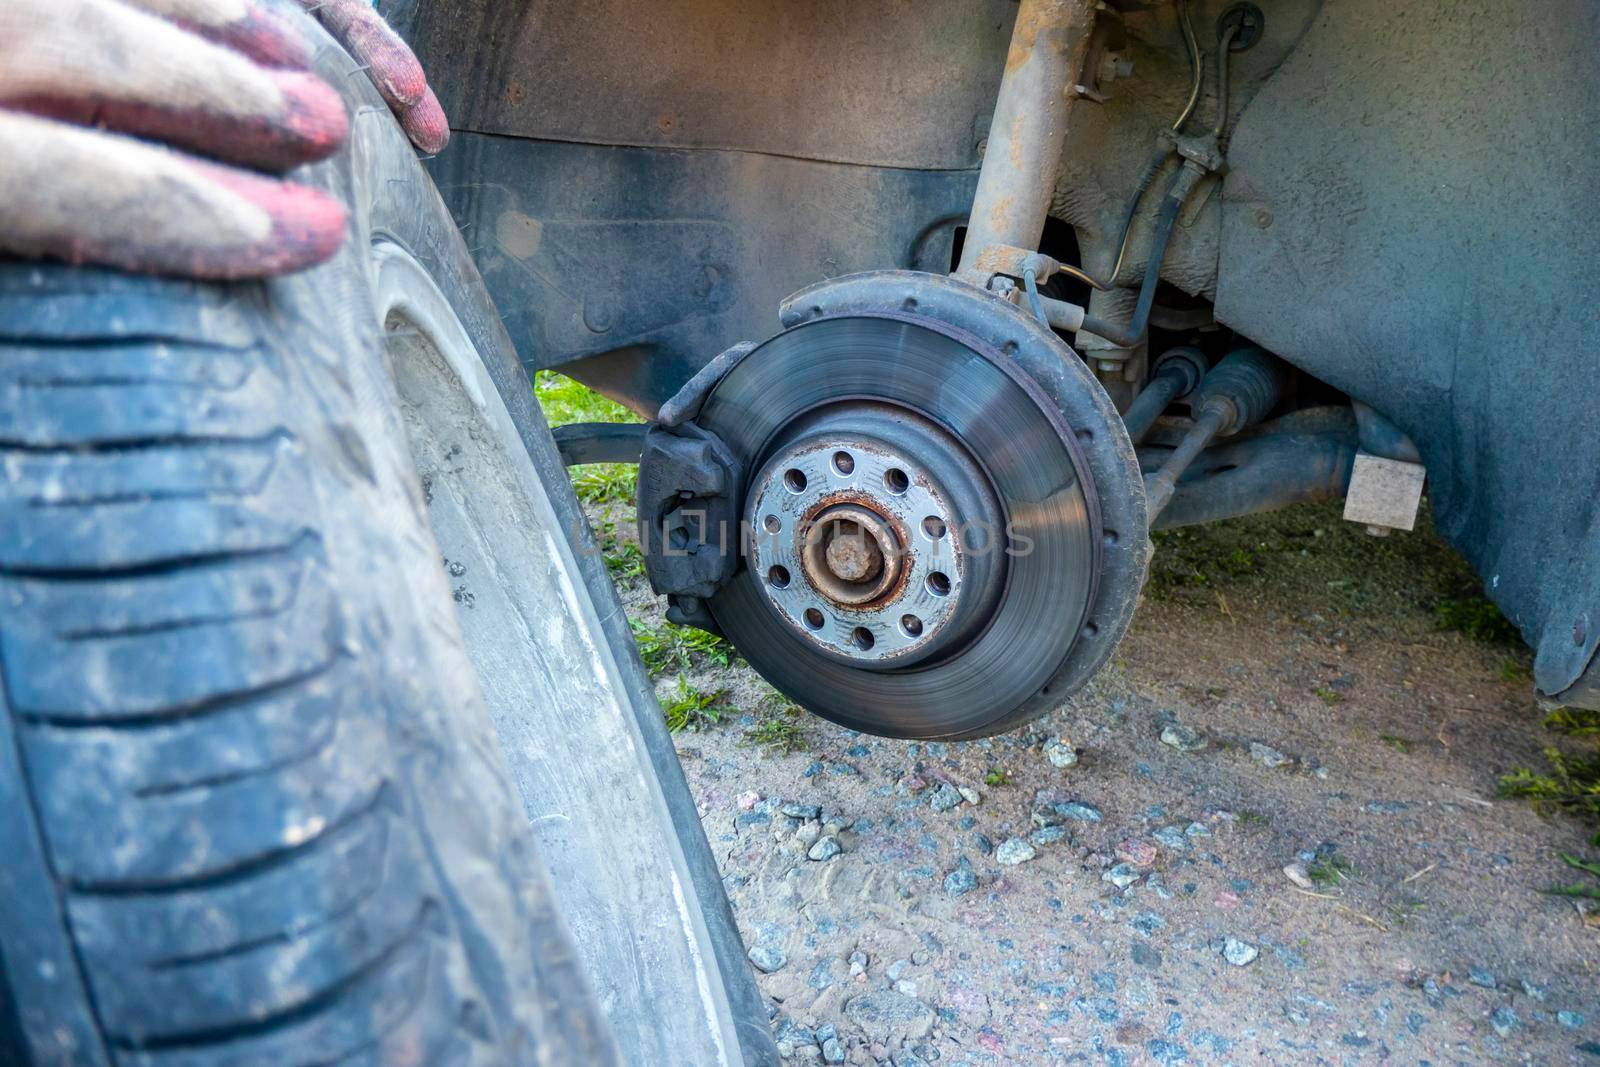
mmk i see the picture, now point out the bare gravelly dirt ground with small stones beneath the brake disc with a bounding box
[595,495,1600,1067]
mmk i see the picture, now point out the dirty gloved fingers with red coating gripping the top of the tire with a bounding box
[0,0,448,278]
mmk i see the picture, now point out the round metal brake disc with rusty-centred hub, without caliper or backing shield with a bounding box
[698,314,1101,737]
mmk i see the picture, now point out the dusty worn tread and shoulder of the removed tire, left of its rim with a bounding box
[0,29,611,1067]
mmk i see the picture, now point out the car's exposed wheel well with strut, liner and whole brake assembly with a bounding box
[384,0,1600,736]
